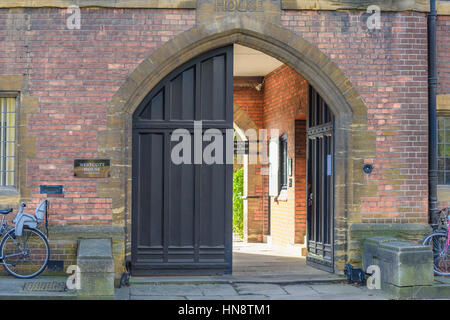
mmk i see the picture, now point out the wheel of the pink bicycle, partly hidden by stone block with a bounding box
[422,231,450,276]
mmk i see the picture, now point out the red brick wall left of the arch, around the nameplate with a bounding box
[0,8,195,228]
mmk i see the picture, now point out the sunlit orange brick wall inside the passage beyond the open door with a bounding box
[234,66,308,245]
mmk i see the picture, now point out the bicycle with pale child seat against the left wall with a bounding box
[0,200,50,279]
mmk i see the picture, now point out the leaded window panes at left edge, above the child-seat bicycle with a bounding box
[0,97,16,187]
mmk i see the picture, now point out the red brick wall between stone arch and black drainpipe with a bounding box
[281,11,430,223]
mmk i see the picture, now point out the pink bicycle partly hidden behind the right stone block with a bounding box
[422,208,450,276]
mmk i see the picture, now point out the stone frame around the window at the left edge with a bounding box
[0,91,20,192]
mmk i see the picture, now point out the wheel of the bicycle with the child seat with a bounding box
[0,228,50,279]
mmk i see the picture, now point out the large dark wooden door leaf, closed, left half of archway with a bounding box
[131,46,233,275]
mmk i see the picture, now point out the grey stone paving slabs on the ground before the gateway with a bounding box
[116,283,389,300]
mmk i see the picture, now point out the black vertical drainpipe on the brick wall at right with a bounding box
[428,0,439,229]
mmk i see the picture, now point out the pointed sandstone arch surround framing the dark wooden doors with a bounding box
[98,15,375,271]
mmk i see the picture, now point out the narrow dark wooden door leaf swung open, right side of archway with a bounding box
[306,86,334,272]
